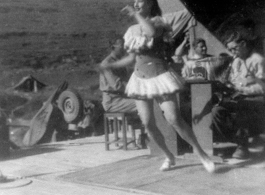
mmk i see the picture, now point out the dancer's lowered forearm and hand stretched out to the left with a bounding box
[100,53,135,69]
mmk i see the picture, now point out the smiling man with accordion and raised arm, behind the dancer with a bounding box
[173,36,214,80]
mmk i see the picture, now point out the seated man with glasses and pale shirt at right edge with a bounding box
[209,31,265,159]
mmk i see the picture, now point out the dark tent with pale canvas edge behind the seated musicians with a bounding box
[158,0,265,55]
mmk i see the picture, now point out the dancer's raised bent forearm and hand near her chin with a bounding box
[122,5,156,37]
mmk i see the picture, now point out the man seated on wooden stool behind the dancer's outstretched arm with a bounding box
[99,37,137,113]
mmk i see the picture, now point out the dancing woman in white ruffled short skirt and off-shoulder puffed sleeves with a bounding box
[102,0,215,172]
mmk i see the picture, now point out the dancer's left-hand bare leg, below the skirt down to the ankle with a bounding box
[136,100,174,160]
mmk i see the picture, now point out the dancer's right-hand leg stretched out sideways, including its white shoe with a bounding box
[160,95,214,172]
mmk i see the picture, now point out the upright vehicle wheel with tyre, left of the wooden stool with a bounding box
[58,89,83,123]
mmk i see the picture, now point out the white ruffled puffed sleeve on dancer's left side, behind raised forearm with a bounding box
[124,25,154,52]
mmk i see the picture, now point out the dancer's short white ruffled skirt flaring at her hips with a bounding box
[125,69,185,99]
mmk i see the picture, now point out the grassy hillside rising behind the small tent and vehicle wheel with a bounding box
[0,0,134,103]
